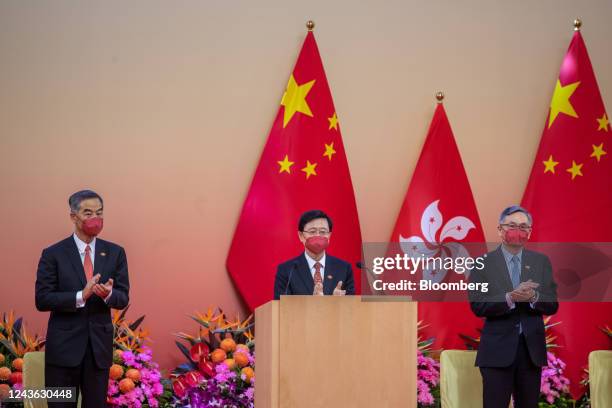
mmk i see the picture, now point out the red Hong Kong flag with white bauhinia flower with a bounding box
[390,103,486,349]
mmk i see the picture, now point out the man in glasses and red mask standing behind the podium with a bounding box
[274,210,355,300]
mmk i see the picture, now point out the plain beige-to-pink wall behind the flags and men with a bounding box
[0,0,612,366]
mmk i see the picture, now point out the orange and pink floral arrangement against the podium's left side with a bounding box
[172,308,255,408]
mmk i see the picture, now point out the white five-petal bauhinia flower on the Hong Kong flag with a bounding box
[399,200,476,282]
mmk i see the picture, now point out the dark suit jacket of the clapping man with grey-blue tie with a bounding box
[469,246,559,367]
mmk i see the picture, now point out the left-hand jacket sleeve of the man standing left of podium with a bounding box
[35,249,77,312]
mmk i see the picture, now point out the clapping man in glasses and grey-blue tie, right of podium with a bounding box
[470,206,559,408]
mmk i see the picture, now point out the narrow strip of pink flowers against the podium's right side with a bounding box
[417,321,441,408]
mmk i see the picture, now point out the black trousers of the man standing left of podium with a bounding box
[45,341,108,408]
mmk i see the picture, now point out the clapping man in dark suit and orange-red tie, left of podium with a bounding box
[36,190,129,408]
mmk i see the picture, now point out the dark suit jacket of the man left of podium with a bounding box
[36,235,130,368]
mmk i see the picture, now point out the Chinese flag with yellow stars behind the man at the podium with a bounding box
[227,31,361,310]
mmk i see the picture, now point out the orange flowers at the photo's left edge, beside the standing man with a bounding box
[0,311,45,406]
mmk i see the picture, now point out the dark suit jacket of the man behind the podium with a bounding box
[274,253,355,300]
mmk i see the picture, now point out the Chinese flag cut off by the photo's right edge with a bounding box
[522,31,612,396]
